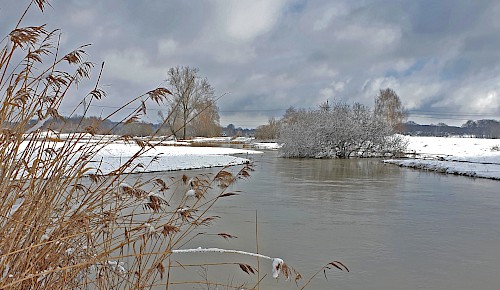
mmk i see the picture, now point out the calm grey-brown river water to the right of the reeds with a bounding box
[146,152,500,289]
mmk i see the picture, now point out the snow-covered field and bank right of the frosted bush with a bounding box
[384,136,500,180]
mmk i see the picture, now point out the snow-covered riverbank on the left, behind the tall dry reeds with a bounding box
[19,132,277,174]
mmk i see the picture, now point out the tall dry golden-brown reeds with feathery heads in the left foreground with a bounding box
[0,0,347,289]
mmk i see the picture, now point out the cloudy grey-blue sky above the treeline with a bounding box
[0,0,500,128]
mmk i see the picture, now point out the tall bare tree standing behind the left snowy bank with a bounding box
[167,66,214,139]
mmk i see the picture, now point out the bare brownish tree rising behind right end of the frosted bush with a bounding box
[375,88,408,132]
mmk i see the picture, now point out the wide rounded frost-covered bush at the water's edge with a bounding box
[279,102,406,158]
